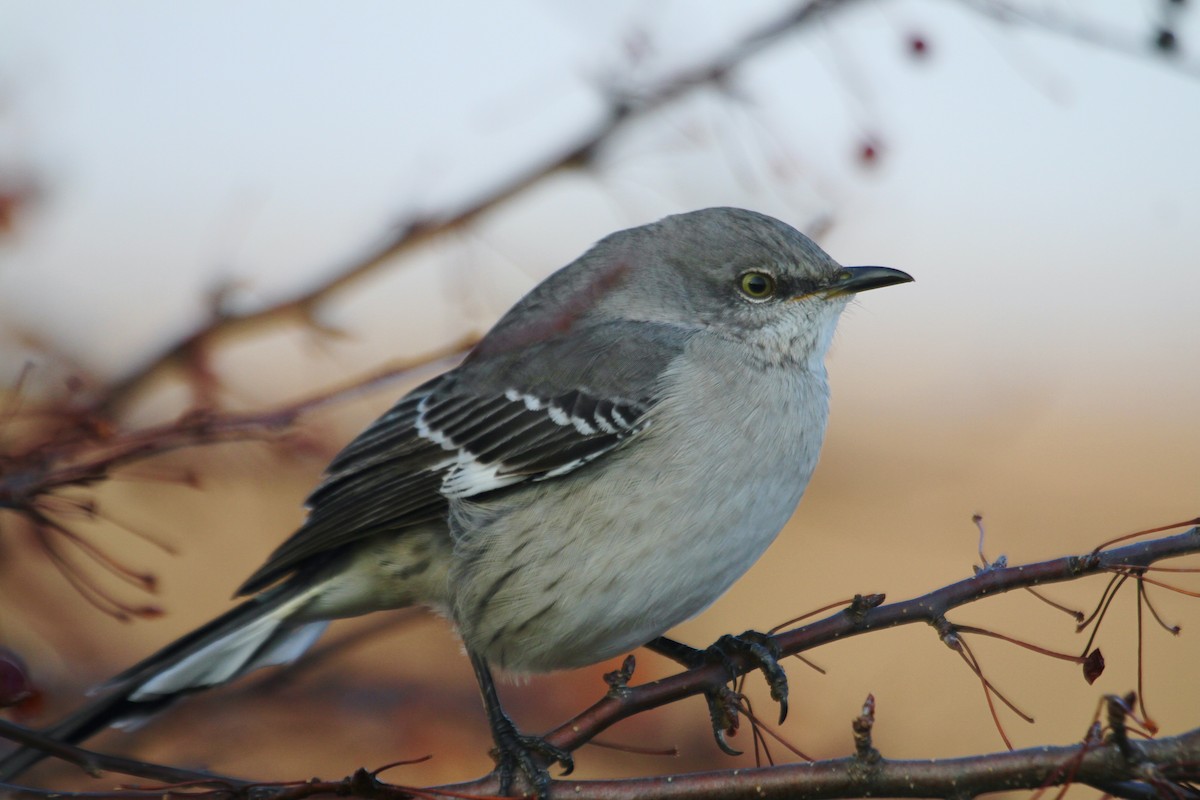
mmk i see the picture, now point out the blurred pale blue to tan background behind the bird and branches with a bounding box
[0,0,1200,787]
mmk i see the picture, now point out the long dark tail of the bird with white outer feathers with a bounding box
[0,581,328,782]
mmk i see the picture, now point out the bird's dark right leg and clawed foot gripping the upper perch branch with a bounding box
[646,631,787,756]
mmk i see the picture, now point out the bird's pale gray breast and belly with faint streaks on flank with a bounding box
[451,335,828,672]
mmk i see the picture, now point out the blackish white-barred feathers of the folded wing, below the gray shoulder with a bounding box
[238,373,649,594]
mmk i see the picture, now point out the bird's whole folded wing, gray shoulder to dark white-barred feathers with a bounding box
[238,326,696,595]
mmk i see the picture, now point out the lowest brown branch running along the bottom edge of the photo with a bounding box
[9,729,1200,800]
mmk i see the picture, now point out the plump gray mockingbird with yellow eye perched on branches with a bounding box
[0,209,912,794]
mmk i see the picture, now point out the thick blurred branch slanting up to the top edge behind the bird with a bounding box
[97,0,854,415]
